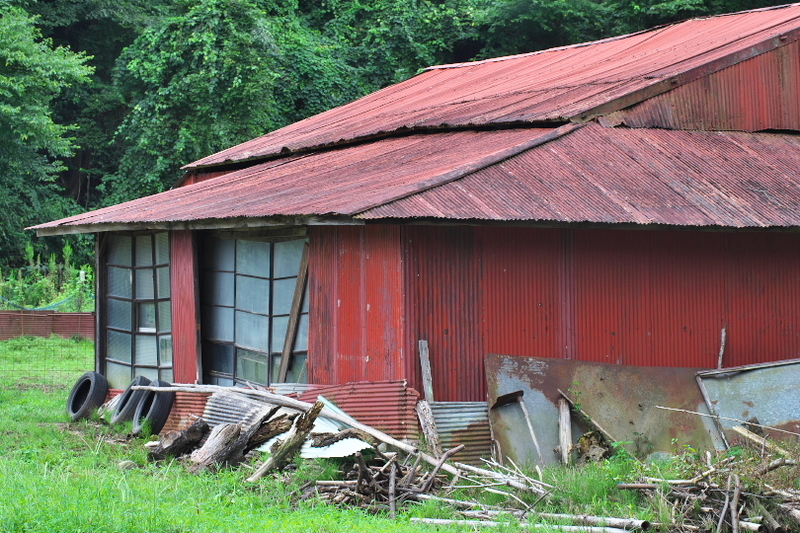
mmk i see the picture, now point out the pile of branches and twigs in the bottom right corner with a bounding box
[617,428,800,533]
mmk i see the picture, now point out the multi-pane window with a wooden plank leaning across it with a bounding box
[200,236,308,386]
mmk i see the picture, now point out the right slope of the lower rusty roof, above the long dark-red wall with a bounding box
[359,124,800,227]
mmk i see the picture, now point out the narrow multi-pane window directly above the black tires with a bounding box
[104,233,173,389]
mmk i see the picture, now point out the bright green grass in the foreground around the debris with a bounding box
[0,338,764,533]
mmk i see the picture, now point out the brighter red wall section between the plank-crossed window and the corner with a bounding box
[309,225,404,384]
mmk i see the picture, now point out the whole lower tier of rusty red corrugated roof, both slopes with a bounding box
[35,123,800,234]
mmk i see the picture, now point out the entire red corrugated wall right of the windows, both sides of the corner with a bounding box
[309,225,800,401]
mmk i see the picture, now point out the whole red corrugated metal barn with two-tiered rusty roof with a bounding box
[34,4,800,408]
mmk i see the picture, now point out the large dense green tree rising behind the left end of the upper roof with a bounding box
[103,0,362,203]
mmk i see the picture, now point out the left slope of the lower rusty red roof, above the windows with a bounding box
[34,128,554,231]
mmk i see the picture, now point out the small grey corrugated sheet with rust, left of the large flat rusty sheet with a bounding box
[430,402,492,465]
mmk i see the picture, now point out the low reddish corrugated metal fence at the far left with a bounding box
[0,311,95,340]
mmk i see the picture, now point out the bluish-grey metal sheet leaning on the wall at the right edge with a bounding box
[698,359,800,442]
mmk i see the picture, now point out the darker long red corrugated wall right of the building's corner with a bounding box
[404,226,800,401]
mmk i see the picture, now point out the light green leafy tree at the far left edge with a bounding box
[0,4,91,266]
